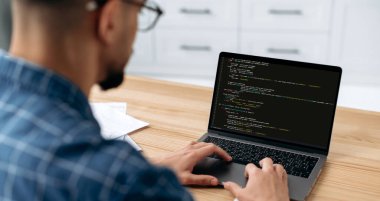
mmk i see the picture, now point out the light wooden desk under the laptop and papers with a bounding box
[91,77,380,201]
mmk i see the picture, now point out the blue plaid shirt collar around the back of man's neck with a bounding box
[0,50,94,119]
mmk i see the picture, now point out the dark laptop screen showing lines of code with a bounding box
[209,53,341,149]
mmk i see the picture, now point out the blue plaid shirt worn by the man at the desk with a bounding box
[0,51,192,201]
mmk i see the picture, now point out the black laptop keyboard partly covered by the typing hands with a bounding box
[205,136,318,178]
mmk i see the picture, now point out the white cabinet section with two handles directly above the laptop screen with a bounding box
[240,0,332,63]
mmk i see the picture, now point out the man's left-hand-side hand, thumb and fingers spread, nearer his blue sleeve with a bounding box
[154,142,232,186]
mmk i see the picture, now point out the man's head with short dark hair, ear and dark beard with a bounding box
[12,0,145,90]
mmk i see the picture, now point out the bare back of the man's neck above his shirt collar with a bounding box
[10,27,99,97]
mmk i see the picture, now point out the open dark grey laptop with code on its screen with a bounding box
[193,52,342,200]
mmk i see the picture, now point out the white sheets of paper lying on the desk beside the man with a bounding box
[91,102,149,151]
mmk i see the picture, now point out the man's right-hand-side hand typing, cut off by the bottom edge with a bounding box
[223,158,289,201]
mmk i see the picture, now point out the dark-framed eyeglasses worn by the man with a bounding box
[86,0,164,32]
